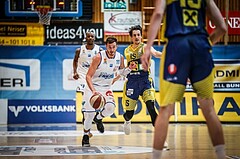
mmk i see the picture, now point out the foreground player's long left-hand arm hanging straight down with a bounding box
[141,0,166,71]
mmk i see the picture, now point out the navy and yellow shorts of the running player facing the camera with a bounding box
[122,77,155,110]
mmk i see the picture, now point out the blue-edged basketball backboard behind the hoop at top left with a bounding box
[5,0,82,17]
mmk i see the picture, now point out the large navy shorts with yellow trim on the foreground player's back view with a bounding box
[160,34,214,106]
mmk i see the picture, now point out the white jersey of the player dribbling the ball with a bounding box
[92,50,121,89]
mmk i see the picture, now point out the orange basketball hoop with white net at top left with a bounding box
[36,6,52,25]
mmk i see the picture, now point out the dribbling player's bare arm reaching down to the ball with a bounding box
[86,53,101,94]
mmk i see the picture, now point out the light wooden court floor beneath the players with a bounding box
[0,123,240,159]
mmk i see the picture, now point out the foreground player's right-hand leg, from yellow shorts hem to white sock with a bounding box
[193,68,226,159]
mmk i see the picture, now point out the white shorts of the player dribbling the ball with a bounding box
[82,85,115,112]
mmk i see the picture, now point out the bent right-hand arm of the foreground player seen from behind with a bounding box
[207,0,227,44]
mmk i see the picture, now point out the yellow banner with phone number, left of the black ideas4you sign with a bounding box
[0,23,44,46]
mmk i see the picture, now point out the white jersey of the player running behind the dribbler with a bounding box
[77,45,100,82]
